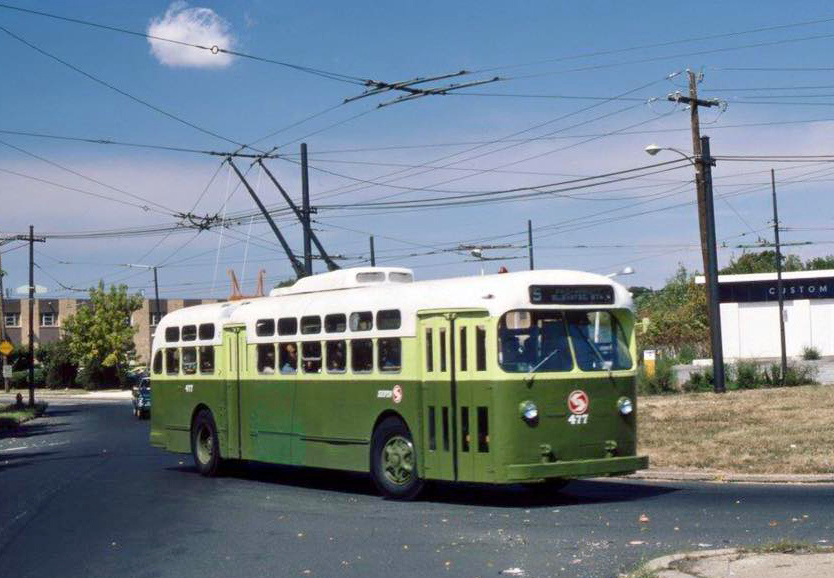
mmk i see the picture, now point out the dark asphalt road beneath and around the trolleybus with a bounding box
[0,401,834,578]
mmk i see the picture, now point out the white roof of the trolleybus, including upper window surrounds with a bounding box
[154,267,632,349]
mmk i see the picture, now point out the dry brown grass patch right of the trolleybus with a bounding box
[638,385,834,474]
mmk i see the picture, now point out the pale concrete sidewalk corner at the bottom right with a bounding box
[634,549,834,578]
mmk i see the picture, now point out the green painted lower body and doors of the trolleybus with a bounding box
[151,310,647,484]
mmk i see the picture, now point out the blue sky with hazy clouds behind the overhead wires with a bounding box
[0,0,834,298]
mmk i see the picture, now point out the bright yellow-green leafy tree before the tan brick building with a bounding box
[64,282,142,387]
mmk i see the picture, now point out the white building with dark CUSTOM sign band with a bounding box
[695,269,834,361]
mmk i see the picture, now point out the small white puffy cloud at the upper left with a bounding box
[148,1,235,68]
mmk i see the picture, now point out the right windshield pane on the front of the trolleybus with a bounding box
[565,311,631,371]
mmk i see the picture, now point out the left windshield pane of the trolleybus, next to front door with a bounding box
[498,311,573,373]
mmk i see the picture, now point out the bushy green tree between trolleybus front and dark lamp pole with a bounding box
[636,265,709,356]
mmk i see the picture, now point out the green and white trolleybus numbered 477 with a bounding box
[151,267,648,498]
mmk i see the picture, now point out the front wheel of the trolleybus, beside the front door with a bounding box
[371,417,423,500]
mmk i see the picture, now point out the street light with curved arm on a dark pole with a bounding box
[644,136,725,393]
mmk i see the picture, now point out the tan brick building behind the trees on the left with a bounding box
[3,299,218,363]
